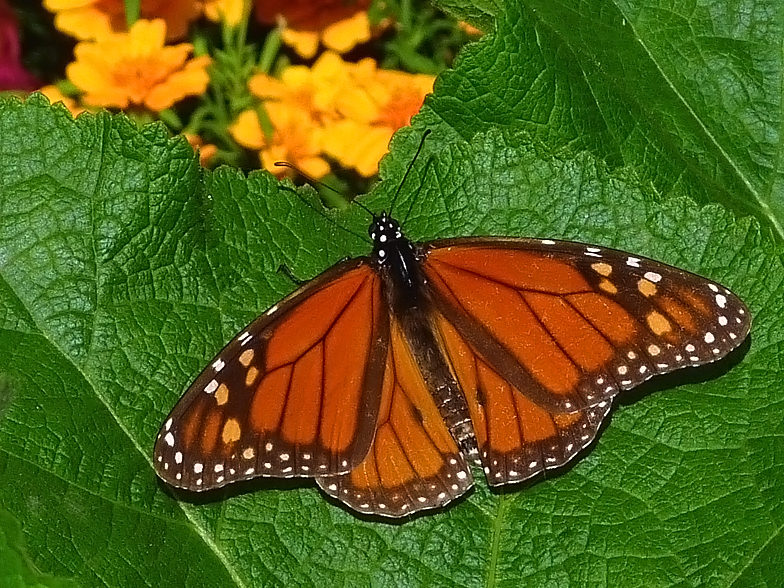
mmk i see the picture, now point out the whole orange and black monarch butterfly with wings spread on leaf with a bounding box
[154,137,750,517]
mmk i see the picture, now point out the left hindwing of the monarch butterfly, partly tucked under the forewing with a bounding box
[317,323,473,517]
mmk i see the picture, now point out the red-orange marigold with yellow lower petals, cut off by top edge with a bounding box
[255,0,371,59]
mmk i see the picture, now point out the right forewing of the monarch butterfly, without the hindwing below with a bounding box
[423,238,750,413]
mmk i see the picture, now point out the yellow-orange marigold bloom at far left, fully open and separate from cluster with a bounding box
[66,20,210,112]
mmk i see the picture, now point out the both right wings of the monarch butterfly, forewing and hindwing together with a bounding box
[423,238,750,485]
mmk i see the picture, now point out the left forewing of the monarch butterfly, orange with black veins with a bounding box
[154,260,389,491]
